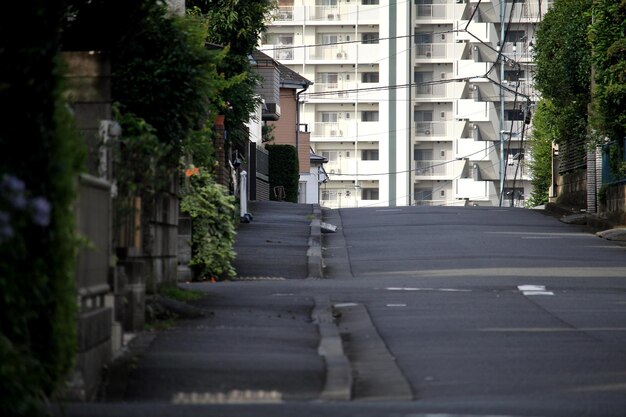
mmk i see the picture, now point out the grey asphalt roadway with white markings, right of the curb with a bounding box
[328,207,626,416]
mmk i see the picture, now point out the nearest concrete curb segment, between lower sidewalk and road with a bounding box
[311,296,352,401]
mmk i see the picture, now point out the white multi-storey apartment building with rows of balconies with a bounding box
[260,0,550,208]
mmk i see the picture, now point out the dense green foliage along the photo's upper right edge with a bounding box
[589,0,626,179]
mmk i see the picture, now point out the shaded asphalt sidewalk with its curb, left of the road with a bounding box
[66,202,342,416]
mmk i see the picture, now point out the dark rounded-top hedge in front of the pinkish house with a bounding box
[266,145,300,203]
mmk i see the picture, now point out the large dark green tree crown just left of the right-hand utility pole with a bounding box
[534,0,592,151]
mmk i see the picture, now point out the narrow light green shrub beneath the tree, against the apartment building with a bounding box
[527,99,557,207]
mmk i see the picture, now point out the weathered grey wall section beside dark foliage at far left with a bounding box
[63,52,115,400]
